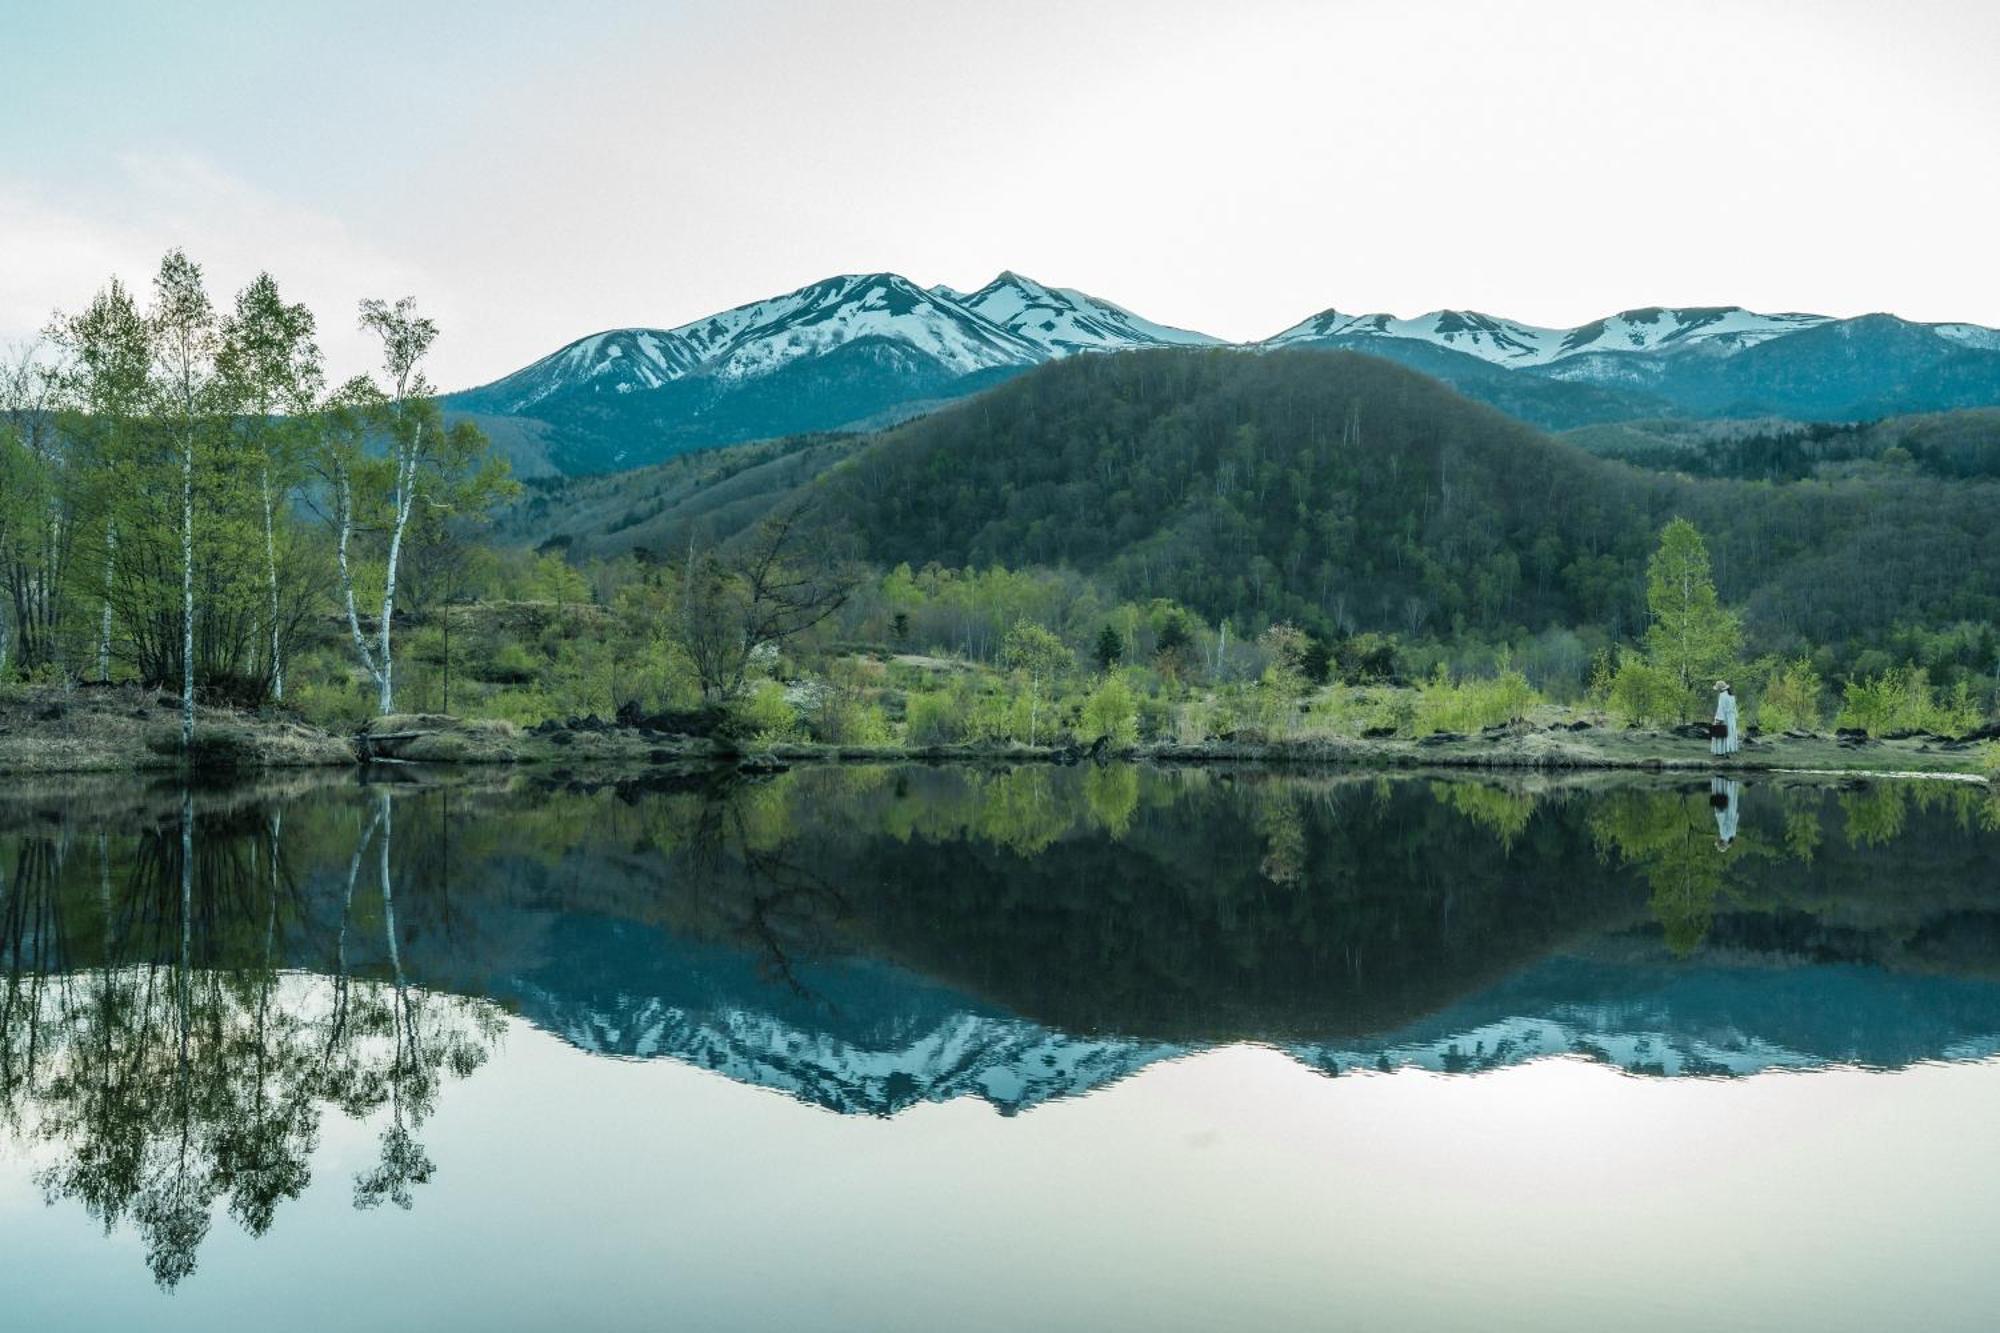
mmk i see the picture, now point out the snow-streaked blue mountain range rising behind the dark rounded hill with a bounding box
[444,272,2000,474]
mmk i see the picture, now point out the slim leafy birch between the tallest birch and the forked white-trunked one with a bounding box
[218,272,324,701]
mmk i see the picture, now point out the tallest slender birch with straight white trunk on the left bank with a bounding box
[148,250,222,751]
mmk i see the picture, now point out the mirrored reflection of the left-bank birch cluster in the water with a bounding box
[0,799,498,1287]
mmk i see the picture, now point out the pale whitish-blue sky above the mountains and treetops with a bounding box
[0,0,2000,386]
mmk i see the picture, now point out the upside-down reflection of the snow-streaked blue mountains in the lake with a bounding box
[488,923,2000,1115]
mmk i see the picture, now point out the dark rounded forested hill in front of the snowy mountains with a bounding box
[514,348,2000,646]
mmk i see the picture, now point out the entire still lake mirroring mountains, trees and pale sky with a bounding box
[0,765,2000,1329]
